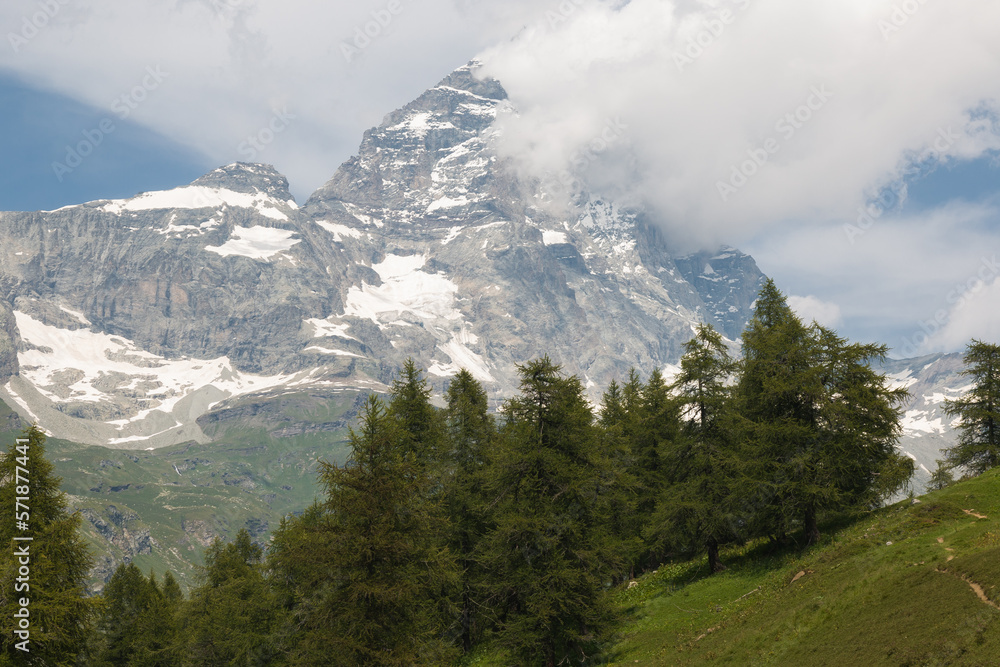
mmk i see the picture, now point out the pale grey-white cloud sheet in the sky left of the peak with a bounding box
[0,0,545,198]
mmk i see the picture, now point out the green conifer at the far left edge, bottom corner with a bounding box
[0,425,95,665]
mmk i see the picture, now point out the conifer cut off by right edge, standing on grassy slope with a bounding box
[945,340,1000,475]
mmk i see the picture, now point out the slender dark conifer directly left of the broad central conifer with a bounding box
[444,369,496,653]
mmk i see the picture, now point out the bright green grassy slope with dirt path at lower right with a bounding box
[465,470,1000,667]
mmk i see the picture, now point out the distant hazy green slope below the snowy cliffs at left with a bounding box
[0,393,358,590]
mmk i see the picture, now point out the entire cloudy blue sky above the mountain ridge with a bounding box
[0,0,1000,357]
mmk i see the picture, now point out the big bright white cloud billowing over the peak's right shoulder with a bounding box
[474,0,1000,250]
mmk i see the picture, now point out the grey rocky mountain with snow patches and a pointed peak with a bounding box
[0,65,763,449]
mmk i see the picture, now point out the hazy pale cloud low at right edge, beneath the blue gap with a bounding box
[744,199,1000,357]
